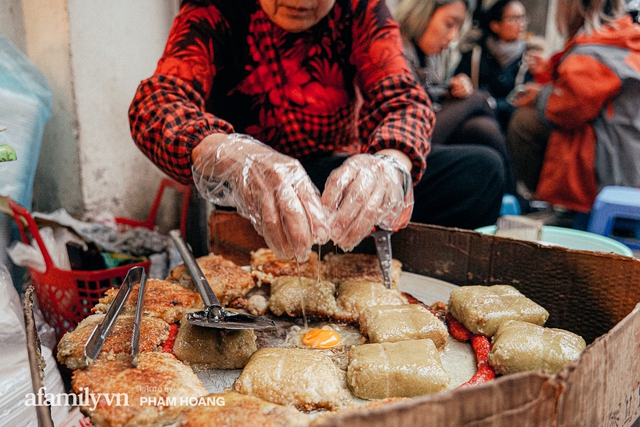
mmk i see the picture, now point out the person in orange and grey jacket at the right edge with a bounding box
[507,0,640,216]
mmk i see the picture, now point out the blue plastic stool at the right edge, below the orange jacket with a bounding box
[587,186,640,250]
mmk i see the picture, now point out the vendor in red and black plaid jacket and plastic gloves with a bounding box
[129,0,504,261]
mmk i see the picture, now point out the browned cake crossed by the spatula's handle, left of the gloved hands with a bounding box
[167,253,255,306]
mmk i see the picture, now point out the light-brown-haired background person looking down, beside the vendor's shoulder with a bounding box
[396,0,526,210]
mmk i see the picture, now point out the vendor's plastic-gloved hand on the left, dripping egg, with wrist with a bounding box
[192,134,329,262]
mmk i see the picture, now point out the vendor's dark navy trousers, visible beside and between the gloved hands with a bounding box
[302,145,504,229]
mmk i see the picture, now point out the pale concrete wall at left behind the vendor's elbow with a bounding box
[0,0,178,224]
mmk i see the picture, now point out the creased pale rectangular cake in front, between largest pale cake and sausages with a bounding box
[347,339,450,399]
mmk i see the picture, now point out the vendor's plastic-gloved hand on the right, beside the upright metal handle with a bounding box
[322,154,413,251]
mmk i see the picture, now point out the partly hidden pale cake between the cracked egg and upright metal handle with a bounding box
[334,281,407,322]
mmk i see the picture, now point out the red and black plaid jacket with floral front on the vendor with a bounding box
[129,0,435,183]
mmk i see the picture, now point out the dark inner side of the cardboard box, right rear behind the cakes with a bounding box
[384,224,640,343]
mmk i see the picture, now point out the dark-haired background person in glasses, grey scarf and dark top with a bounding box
[456,0,544,131]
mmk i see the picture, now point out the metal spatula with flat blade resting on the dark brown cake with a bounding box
[169,230,276,329]
